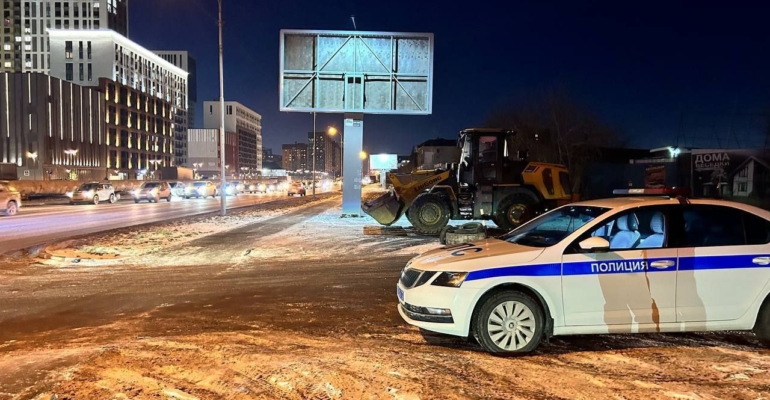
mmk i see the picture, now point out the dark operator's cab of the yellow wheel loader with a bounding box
[458,128,527,185]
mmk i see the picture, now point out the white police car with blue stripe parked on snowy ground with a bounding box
[397,190,770,353]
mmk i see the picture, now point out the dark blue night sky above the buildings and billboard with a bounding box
[130,0,770,154]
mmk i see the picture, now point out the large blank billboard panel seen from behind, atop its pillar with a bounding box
[280,29,434,115]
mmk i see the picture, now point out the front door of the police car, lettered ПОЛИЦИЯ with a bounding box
[562,206,677,332]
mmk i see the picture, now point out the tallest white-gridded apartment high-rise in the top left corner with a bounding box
[0,0,128,73]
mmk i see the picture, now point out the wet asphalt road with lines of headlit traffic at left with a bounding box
[0,193,328,254]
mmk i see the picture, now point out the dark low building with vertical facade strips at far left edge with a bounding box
[0,72,107,180]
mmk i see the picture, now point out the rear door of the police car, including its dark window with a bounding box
[677,204,770,322]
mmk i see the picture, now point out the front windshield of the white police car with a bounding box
[503,206,609,247]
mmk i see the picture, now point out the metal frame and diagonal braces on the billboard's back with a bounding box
[278,29,435,115]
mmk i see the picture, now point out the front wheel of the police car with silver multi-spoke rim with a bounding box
[473,291,545,354]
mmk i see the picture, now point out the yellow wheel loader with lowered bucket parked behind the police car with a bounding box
[362,128,572,234]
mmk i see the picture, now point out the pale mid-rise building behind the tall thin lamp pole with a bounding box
[203,101,262,172]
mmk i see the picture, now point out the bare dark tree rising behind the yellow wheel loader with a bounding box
[487,89,621,192]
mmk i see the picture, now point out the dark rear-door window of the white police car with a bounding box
[682,205,746,247]
